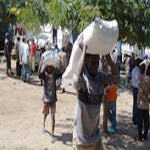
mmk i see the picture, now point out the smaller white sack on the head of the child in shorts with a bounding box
[41,50,60,71]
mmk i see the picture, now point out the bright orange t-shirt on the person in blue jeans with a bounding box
[108,85,117,102]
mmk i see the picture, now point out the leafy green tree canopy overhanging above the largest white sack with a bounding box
[19,0,150,48]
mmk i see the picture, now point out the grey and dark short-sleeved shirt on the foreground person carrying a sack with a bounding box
[73,67,117,144]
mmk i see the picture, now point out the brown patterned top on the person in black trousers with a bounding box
[137,75,150,110]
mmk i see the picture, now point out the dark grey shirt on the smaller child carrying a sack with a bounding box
[41,69,58,103]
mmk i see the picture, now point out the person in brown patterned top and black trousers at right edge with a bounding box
[137,64,150,141]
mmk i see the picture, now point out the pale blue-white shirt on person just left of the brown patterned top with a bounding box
[131,66,141,88]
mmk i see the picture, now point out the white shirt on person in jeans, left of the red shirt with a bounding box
[21,42,29,64]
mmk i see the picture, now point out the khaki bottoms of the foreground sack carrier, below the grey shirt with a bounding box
[73,127,103,150]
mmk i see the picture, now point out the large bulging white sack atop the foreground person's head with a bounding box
[83,18,119,55]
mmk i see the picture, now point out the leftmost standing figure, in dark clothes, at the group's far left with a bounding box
[4,33,13,77]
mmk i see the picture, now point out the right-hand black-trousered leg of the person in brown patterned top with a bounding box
[143,110,149,140]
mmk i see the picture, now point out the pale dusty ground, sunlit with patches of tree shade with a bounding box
[0,58,150,150]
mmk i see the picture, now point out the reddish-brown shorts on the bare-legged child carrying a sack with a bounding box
[43,102,56,115]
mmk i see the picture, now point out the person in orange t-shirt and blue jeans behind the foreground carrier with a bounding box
[107,84,117,133]
